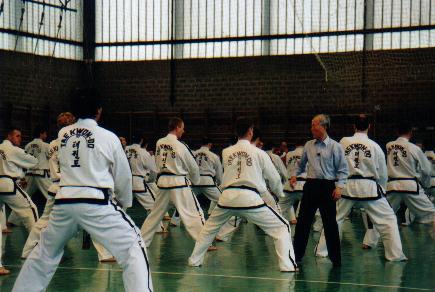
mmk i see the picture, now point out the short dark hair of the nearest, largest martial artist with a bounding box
[71,88,102,119]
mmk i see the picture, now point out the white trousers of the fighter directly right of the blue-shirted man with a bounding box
[316,197,407,261]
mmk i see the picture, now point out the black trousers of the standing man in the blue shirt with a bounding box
[294,179,341,264]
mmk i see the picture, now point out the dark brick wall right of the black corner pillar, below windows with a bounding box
[95,49,435,151]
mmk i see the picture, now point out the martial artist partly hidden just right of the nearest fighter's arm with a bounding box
[125,137,166,232]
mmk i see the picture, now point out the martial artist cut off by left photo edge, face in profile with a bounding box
[0,129,38,274]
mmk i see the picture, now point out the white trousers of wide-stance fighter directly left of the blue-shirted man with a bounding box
[189,205,297,272]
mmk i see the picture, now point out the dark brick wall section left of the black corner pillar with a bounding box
[0,50,83,141]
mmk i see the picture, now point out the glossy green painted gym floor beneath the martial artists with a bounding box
[0,201,435,292]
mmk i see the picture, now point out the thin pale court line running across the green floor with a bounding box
[5,265,433,291]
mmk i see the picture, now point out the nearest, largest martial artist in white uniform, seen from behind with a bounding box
[12,91,152,292]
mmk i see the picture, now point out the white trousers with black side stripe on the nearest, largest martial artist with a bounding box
[12,202,152,292]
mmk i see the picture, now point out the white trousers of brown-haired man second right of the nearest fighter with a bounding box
[141,186,205,247]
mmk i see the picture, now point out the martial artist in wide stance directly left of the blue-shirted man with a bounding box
[189,119,297,272]
